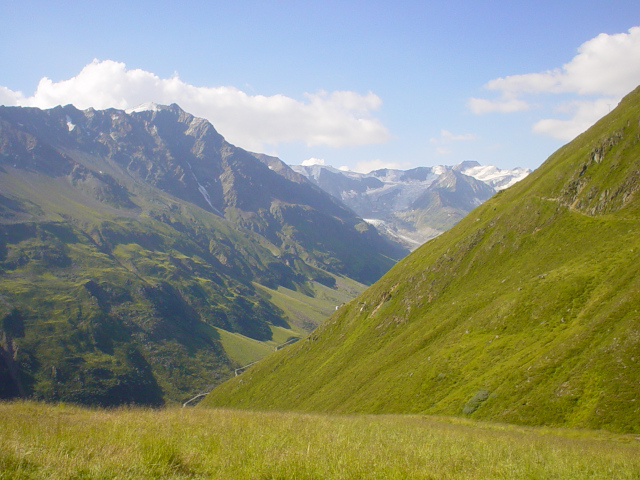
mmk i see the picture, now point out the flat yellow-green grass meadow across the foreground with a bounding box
[0,402,640,480]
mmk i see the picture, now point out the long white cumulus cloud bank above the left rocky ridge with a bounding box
[0,60,391,150]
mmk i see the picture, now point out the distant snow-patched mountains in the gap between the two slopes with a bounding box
[291,161,531,249]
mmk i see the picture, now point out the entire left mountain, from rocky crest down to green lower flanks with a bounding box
[0,104,405,405]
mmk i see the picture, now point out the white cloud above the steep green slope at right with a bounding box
[467,27,640,140]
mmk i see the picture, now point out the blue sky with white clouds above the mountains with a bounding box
[0,0,640,173]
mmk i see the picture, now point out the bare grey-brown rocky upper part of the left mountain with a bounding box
[0,104,406,283]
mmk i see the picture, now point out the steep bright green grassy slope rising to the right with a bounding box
[204,89,640,433]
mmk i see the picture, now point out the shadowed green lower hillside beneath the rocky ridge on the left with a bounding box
[0,172,364,405]
